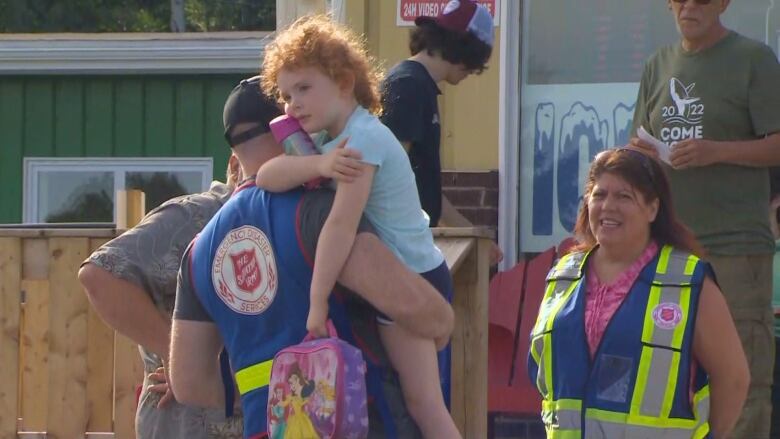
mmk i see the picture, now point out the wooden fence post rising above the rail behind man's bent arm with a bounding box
[114,190,145,439]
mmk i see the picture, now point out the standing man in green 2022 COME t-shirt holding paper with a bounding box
[631,0,780,438]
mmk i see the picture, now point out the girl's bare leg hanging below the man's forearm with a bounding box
[378,324,461,439]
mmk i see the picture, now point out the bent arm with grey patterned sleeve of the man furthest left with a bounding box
[78,198,218,358]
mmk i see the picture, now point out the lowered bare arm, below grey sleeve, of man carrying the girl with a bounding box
[170,319,225,408]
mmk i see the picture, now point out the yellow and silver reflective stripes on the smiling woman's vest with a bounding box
[530,246,709,439]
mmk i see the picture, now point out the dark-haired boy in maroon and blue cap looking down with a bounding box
[381,0,503,263]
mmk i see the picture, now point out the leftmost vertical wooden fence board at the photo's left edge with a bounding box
[0,238,22,439]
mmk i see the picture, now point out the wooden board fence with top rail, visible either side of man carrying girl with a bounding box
[0,196,490,439]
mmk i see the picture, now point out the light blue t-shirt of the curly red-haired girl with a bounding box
[312,105,444,273]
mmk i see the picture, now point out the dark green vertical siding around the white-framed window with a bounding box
[0,75,244,223]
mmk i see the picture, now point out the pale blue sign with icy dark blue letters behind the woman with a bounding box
[519,83,637,252]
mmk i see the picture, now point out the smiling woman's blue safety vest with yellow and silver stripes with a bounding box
[528,246,709,439]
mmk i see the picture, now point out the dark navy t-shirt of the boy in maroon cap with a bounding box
[380,60,441,227]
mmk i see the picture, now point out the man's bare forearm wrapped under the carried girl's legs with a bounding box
[339,233,455,341]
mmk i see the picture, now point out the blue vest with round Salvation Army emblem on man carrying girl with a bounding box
[190,186,414,438]
